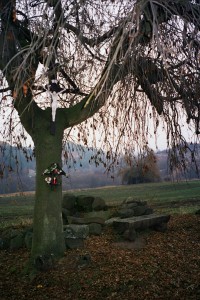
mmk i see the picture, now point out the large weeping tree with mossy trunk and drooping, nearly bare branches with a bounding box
[0,0,200,268]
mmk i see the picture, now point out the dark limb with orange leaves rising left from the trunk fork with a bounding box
[0,1,44,133]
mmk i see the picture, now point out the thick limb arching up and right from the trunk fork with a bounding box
[59,49,167,128]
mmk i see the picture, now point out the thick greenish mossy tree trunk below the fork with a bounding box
[31,129,65,261]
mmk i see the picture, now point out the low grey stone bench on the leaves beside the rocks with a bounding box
[113,214,170,241]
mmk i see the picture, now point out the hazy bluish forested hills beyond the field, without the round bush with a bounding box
[0,143,200,194]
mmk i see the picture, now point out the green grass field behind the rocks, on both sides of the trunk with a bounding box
[0,180,200,227]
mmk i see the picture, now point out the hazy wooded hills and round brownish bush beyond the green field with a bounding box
[0,143,200,194]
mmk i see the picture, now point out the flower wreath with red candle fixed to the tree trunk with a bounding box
[43,163,66,187]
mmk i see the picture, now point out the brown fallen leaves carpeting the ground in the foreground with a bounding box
[0,215,200,300]
